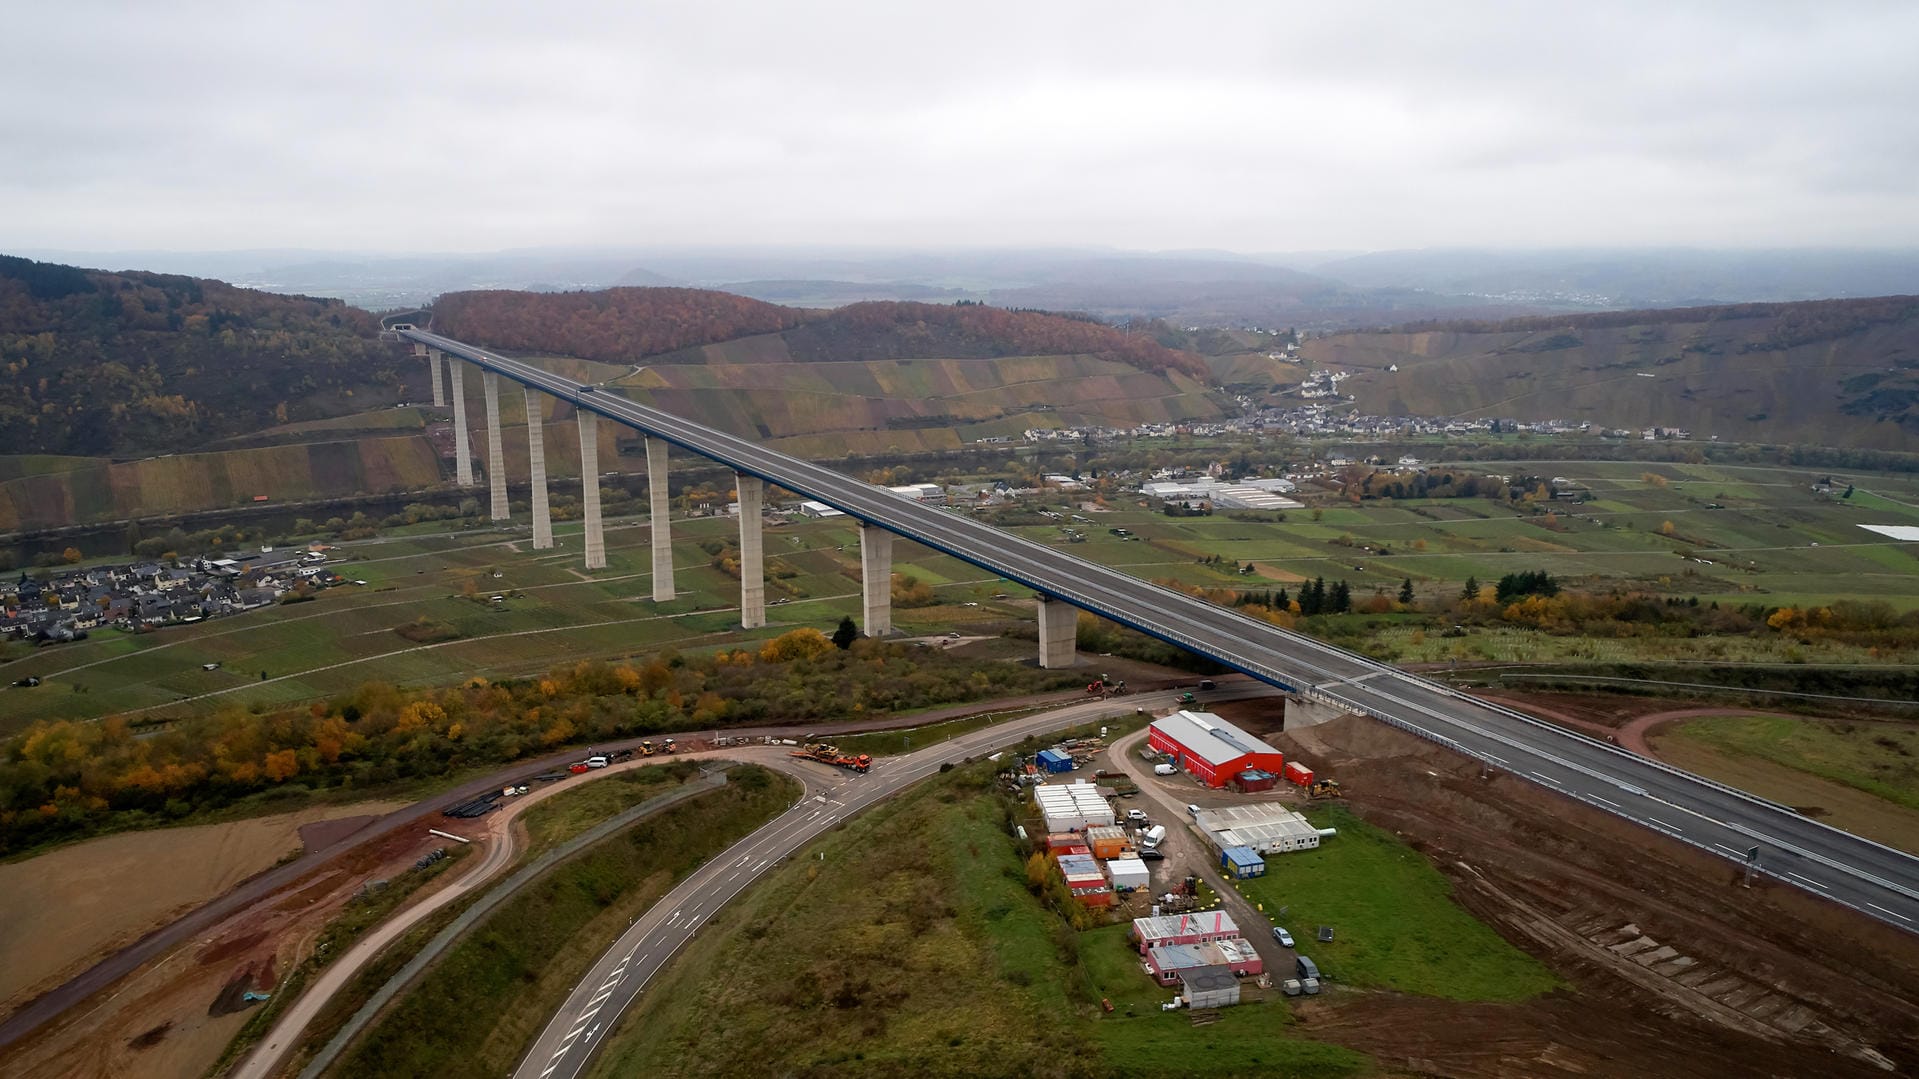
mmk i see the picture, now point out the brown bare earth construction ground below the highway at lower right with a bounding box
[1219,691,1919,1079]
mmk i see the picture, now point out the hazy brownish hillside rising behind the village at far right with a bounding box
[1301,296,1919,449]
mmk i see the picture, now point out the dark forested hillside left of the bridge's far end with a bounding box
[0,255,405,457]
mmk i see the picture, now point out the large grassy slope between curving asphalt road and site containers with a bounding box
[593,768,1368,1077]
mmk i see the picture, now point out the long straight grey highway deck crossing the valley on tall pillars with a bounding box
[403,330,1919,933]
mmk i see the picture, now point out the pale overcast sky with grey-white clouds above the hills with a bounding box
[0,0,1919,252]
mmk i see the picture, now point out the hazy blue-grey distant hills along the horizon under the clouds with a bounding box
[18,248,1919,330]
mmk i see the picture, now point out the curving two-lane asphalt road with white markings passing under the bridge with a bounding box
[514,685,1272,1079]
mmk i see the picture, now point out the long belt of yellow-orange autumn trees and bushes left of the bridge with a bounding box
[0,630,1080,856]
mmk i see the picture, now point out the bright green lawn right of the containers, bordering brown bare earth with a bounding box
[1242,806,1560,1000]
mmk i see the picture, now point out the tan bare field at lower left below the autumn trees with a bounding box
[0,803,397,1014]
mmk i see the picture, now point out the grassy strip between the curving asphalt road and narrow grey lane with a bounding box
[330,766,798,1077]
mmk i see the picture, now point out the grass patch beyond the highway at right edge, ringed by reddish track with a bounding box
[1660,716,1919,808]
